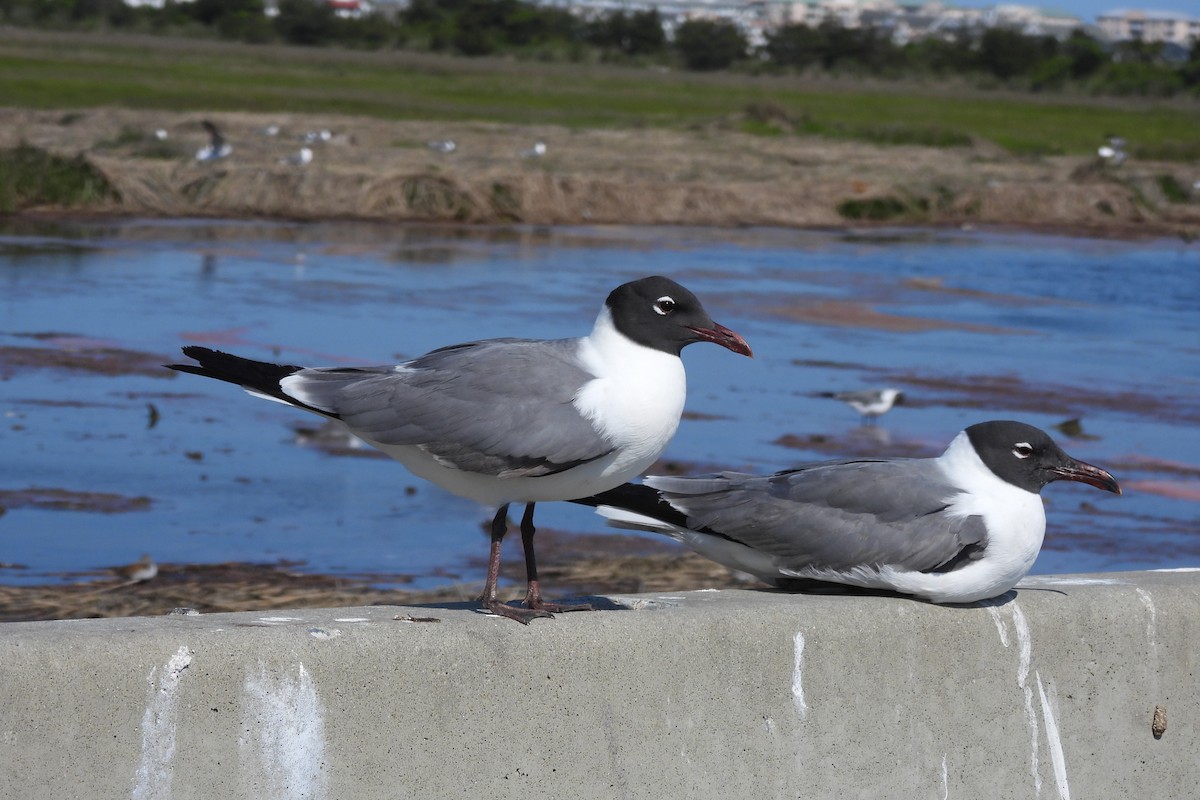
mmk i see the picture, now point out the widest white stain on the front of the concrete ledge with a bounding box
[238,662,329,800]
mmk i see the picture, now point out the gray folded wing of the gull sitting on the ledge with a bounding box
[646,459,986,571]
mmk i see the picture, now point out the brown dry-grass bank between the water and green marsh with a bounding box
[0,109,1200,237]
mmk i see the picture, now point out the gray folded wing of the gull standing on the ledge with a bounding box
[286,339,613,476]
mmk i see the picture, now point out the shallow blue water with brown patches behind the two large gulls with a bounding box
[0,221,1200,585]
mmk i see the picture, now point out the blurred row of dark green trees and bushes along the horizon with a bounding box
[0,0,1200,97]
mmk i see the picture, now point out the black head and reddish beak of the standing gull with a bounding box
[605,275,752,356]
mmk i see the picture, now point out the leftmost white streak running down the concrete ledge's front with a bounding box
[130,646,194,800]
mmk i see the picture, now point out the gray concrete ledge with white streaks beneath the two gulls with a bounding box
[0,571,1200,800]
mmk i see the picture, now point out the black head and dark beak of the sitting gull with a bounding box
[966,420,1121,494]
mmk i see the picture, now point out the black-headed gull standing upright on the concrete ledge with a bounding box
[169,276,751,622]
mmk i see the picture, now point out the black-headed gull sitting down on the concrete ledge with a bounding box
[576,421,1121,603]
